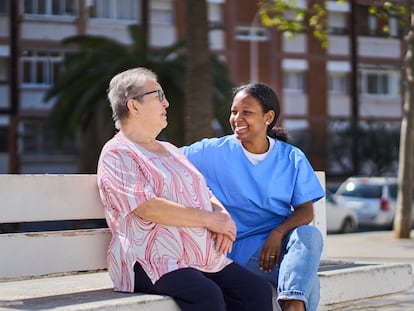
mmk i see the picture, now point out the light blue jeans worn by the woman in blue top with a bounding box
[246,225,323,311]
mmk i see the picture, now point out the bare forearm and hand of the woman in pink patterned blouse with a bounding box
[134,198,236,241]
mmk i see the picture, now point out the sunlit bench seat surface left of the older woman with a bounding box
[0,272,180,311]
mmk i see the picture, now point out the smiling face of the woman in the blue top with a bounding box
[229,91,274,145]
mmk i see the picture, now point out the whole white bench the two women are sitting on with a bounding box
[0,172,411,311]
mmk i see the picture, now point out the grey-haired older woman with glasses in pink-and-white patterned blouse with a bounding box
[97,68,272,311]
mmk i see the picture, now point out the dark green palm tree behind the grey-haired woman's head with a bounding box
[45,25,185,173]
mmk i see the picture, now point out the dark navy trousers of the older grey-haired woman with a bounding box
[134,263,273,311]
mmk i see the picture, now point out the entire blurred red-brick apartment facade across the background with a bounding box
[0,0,405,178]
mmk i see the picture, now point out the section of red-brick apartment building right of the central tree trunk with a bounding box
[226,0,405,175]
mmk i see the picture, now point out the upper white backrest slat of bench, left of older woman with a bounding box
[0,174,104,223]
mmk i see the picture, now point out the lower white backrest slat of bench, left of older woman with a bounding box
[0,228,111,281]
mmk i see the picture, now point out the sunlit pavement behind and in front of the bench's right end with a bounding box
[325,230,414,311]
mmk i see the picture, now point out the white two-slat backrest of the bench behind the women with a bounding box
[0,172,326,280]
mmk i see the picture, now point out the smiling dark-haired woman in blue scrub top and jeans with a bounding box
[182,83,324,311]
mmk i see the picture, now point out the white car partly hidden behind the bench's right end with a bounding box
[326,190,358,233]
